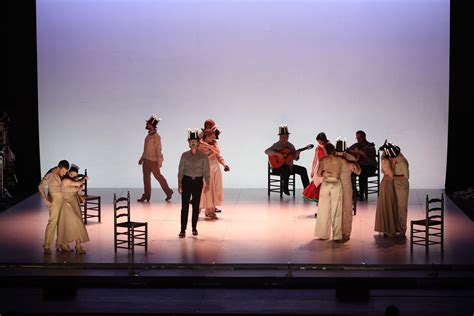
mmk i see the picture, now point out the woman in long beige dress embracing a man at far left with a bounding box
[58,165,89,254]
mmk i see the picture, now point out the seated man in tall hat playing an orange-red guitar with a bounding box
[265,125,309,195]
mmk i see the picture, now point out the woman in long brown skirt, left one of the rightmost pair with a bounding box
[374,144,398,236]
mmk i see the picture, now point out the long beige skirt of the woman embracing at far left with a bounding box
[58,193,89,245]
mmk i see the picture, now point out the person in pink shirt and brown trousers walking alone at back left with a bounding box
[137,115,173,202]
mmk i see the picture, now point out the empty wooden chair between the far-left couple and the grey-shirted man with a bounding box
[114,191,148,255]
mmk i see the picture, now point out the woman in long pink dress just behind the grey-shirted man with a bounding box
[199,126,230,219]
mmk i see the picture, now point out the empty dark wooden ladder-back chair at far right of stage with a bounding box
[410,193,444,252]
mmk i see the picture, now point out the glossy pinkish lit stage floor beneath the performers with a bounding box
[0,189,474,266]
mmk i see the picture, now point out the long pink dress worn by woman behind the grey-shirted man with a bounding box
[199,140,224,209]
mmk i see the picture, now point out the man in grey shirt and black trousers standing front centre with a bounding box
[178,129,210,238]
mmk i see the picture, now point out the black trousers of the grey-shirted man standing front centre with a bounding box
[181,176,203,231]
